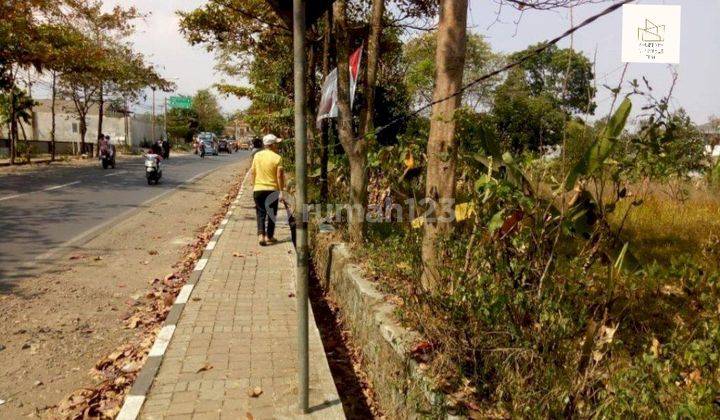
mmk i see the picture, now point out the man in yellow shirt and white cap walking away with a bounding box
[250,134,285,246]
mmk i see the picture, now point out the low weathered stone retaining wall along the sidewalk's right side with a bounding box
[313,226,455,419]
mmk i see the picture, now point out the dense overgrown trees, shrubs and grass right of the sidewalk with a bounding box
[176,0,720,418]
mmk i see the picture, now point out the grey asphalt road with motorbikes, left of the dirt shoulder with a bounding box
[0,151,249,289]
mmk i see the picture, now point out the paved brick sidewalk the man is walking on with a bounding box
[140,178,344,419]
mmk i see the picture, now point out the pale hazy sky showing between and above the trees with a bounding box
[101,0,720,123]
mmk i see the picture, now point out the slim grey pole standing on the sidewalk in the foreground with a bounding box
[293,0,310,413]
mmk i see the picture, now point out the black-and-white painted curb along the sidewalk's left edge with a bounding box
[116,170,250,420]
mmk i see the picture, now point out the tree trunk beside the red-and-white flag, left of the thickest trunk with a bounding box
[333,0,367,243]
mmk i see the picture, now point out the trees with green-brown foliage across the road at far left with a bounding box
[0,0,174,163]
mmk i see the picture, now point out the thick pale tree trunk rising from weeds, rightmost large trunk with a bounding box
[422,0,468,291]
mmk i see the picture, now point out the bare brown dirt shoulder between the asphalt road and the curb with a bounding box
[0,160,248,419]
